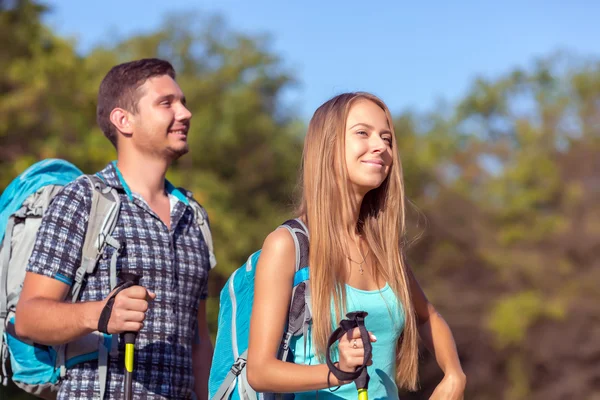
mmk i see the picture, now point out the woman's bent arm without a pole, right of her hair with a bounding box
[408,268,467,399]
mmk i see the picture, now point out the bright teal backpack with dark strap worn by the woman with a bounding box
[208,219,312,400]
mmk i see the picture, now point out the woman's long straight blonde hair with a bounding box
[298,92,418,390]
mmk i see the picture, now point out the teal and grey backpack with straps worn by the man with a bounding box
[0,159,216,399]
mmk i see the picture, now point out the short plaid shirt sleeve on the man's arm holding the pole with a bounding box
[27,178,92,285]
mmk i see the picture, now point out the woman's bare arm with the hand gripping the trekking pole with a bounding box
[246,229,363,393]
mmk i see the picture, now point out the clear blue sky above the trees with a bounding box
[46,0,600,119]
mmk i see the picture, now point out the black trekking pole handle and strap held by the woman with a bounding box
[326,311,373,400]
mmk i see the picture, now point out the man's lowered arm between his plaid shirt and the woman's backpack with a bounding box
[192,300,213,400]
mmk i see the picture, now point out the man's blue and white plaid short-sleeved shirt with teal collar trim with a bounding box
[27,163,210,400]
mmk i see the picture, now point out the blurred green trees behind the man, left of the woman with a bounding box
[0,1,302,393]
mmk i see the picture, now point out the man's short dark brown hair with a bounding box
[96,58,175,148]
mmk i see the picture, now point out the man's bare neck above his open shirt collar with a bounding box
[117,154,169,203]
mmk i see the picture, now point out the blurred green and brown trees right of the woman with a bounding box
[408,54,600,400]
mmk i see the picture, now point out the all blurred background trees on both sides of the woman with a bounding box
[0,0,600,400]
